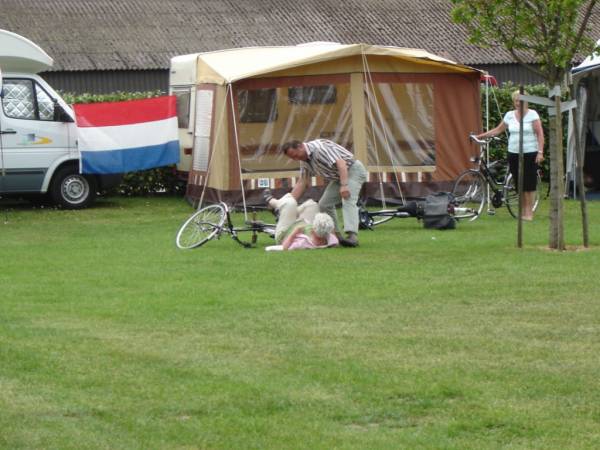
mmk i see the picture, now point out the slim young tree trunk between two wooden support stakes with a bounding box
[549,95,565,250]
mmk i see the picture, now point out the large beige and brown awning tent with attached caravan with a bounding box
[170,43,481,202]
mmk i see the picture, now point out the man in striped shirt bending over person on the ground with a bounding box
[281,139,367,247]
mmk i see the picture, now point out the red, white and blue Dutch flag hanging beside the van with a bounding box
[74,96,179,174]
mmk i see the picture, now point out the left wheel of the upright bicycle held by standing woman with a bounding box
[452,169,486,221]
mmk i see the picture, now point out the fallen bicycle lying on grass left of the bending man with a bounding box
[175,202,275,249]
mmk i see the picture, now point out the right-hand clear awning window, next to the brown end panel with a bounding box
[366,82,435,167]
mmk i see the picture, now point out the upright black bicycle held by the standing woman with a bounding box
[452,135,542,220]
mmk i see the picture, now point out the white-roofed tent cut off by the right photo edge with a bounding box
[566,41,600,195]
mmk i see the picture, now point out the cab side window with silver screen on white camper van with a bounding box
[2,78,54,120]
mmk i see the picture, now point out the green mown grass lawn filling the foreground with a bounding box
[0,198,600,450]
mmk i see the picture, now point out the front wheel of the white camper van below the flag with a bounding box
[50,167,96,209]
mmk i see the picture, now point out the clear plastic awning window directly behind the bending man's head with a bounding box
[235,77,353,173]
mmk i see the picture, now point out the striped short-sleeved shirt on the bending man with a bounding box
[300,139,354,181]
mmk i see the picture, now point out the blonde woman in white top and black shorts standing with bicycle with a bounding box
[476,91,544,220]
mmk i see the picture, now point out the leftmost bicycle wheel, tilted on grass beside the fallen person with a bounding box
[175,205,225,249]
